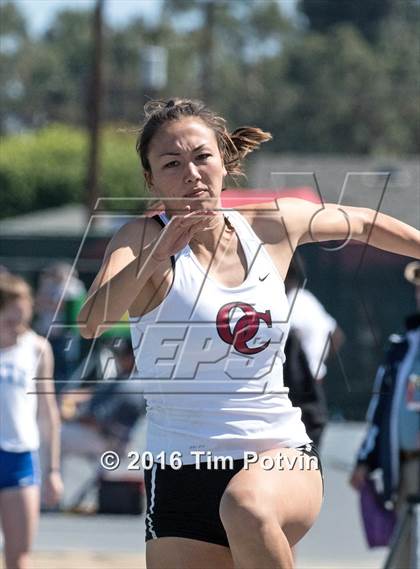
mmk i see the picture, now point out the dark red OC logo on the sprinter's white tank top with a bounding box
[216,302,272,355]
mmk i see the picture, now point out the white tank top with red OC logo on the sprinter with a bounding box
[130,211,310,464]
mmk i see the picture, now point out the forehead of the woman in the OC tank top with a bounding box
[150,117,217,155]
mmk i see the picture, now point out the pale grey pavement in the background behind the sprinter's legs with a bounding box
[0,422,387,569]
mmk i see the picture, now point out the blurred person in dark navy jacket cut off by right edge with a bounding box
[350,261,420,567]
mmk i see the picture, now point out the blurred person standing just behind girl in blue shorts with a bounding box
[34,262,86,393]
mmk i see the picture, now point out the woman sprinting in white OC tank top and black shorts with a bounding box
[79,99,420,569]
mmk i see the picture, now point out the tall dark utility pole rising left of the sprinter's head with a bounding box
[86,0,105,226]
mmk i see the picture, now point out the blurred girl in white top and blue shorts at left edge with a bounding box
[0,272,62,569]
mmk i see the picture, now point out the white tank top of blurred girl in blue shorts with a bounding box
[0,330,39,452]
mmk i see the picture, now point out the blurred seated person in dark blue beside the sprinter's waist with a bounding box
[61,339,146,463]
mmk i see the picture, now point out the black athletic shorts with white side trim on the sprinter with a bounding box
[145,444,324,547]
